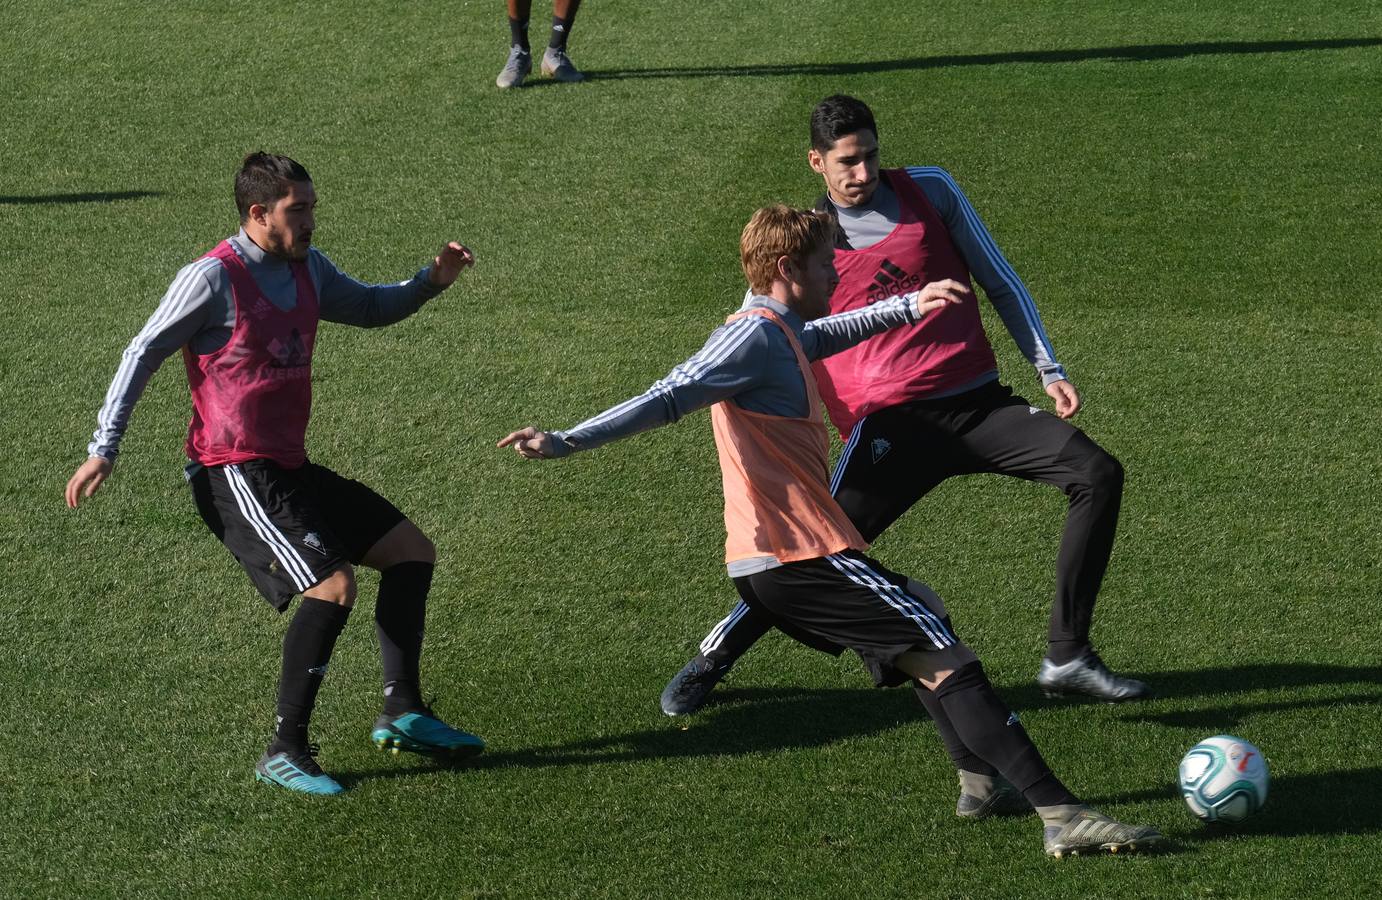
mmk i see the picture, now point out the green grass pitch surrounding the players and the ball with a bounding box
[0,0,1382,899]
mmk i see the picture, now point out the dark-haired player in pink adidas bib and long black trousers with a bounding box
[662,95,1148,724]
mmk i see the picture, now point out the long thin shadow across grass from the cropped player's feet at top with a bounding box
[585,37,1382,80]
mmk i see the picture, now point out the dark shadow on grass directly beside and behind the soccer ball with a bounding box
[1085,767,1382,843]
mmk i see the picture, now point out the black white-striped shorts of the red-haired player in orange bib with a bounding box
[734,550,958,687]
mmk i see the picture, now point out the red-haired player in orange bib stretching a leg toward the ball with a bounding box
[499,206,1161,857]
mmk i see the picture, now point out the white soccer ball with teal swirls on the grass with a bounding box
[1180,734,1269,823]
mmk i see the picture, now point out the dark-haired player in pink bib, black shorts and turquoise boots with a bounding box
[66,152,484,794]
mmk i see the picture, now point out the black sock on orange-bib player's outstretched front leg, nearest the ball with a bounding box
[934,661,1079,806]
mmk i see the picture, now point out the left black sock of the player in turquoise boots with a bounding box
[269,597,350,753]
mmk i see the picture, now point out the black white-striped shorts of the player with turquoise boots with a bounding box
[188,459,406,612]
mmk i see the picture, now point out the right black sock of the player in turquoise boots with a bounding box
[375,563,434,715]
